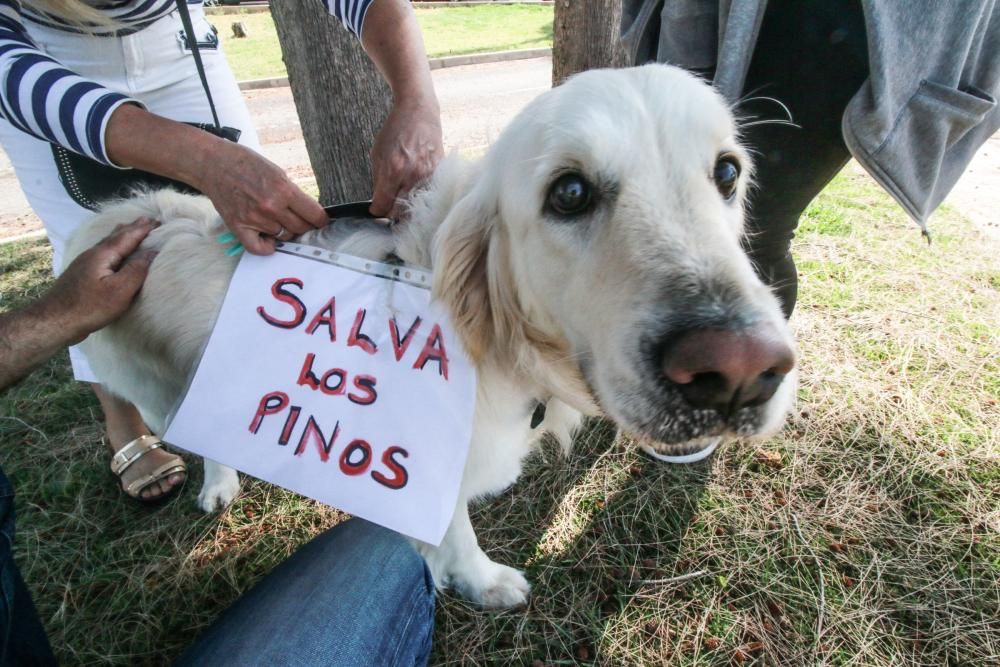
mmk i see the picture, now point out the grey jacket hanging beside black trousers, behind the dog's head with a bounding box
[622,0,1000,227]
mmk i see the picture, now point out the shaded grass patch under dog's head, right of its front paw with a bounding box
[432,421,709,664]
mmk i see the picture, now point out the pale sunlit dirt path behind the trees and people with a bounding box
[0,58,1000,242]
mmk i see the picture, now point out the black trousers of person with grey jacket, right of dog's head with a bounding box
[736,0,868,317]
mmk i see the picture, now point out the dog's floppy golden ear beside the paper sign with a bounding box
[434,187,498,362]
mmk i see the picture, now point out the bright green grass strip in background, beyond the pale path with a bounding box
[209,5,552,81]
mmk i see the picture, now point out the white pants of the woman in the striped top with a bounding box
[0,5,260,382]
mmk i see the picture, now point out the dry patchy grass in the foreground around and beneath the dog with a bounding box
[0,163,1000,666]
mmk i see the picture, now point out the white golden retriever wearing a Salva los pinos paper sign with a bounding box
[67,65,795,607]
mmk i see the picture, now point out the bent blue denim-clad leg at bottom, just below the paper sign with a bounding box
[178,519,435,667]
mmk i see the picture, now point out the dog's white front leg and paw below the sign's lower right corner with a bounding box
[417,499,531,609]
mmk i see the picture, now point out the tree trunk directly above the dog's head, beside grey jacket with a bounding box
[552,0,624,86]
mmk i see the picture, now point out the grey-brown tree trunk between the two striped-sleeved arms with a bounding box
[271,0,392,204]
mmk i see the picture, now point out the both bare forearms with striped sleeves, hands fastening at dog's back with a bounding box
[105,0,443,254]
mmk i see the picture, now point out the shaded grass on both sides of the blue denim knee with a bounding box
[7,356,707,665]
